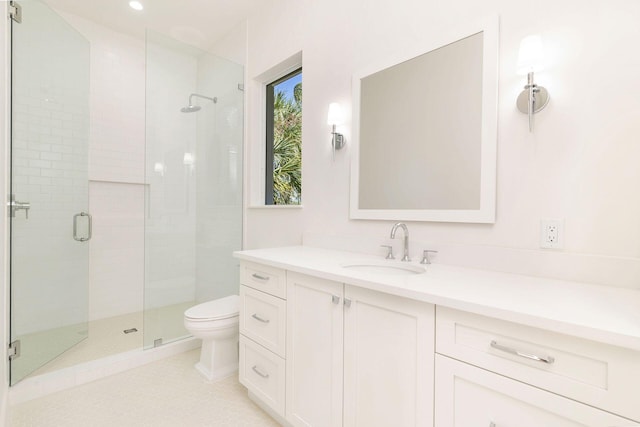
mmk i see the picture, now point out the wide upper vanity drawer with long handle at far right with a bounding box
[436,306,640,421]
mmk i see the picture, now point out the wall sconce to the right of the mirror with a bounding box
[516,35,549,132]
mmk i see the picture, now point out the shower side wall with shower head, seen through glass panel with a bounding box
[191,54,244,301]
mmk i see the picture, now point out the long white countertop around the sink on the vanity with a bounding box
[234,246,640,351]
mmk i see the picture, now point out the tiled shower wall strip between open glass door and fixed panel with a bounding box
[63,14,145,320]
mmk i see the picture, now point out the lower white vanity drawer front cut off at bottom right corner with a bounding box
[435,355,634,427]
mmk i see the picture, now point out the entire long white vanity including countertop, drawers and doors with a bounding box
[238,247,640,427]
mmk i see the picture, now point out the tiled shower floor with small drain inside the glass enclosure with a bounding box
[20,301,195,377]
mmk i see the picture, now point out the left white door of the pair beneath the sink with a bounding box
[285,272,343,427]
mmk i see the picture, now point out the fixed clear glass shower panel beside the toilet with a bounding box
[144,32,244,348]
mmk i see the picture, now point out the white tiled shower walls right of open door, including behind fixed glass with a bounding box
[64,14,243,319]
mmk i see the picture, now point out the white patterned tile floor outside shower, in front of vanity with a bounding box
[9,349,278,427]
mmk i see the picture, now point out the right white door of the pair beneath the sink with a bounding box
[344,286,435,427]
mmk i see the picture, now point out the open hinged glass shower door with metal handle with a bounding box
[7,0,91,384]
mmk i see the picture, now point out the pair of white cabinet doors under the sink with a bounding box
[286,272,434,427]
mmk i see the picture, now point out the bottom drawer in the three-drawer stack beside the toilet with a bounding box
[239,335,285,417]
